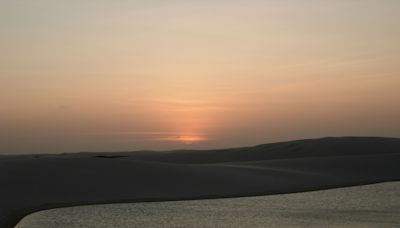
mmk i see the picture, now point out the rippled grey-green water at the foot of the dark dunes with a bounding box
[17,182,400,228]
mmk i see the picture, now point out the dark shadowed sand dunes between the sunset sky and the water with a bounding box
[0,137,400,228]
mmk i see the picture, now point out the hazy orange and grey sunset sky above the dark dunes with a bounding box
[0,0,400,154]
